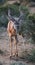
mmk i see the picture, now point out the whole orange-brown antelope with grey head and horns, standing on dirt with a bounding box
[6,9,23,56]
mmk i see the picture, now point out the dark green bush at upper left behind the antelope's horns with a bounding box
[0,4,20,17]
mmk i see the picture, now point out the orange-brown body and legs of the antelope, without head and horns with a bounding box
[7,20,18,57]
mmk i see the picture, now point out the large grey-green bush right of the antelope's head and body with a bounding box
[19,6,35,43]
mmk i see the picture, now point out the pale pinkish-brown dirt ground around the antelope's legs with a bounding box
[0,27,35,65]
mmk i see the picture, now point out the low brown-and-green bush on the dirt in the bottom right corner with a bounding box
[20,49,35,62]
